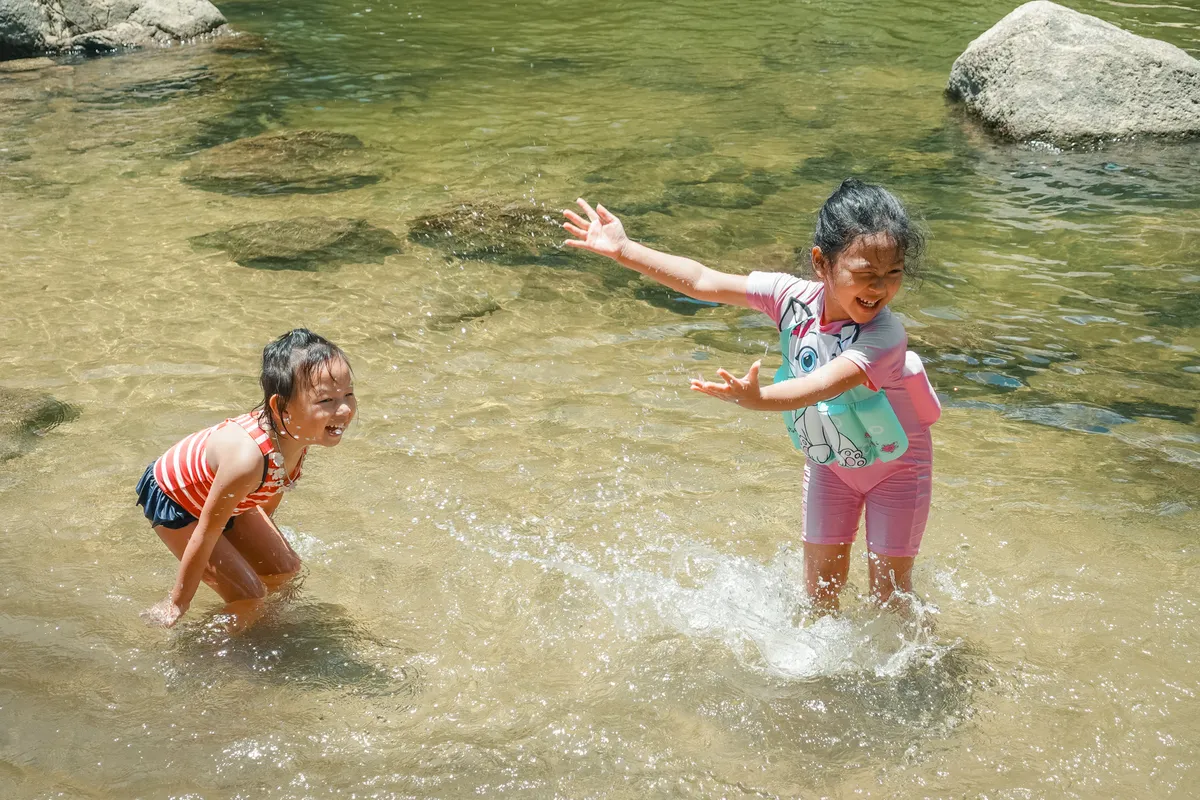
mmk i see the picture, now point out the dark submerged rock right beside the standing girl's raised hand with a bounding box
[408,203,565,265]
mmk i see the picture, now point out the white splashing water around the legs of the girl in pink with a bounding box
[450,524,956,680]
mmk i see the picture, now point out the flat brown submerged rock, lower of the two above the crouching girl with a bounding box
[191,217,403,270]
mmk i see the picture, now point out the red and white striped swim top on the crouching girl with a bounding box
[154,414,305,518]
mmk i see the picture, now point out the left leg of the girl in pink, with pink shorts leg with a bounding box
[803,462,864,612]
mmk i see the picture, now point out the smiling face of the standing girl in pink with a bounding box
[812,234,904,325]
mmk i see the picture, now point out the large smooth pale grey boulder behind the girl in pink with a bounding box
[946,0,1200,146]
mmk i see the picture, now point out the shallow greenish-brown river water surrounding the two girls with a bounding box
[0,0,1200,799]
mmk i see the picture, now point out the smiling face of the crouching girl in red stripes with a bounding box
[271,359,359,447]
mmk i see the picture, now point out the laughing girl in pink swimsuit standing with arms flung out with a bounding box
[563,179,938,610]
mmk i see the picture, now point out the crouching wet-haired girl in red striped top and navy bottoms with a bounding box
[137,327,358,627]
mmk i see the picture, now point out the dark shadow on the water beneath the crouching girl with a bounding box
[164,600,421,698]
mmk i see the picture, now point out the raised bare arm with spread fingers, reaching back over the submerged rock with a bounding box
[563,198,750,307]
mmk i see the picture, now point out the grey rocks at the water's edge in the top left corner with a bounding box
[0,0,226,60]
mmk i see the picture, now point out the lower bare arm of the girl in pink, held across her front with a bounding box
[691,357,866,411]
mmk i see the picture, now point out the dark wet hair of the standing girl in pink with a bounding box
[812,178,925,276]
